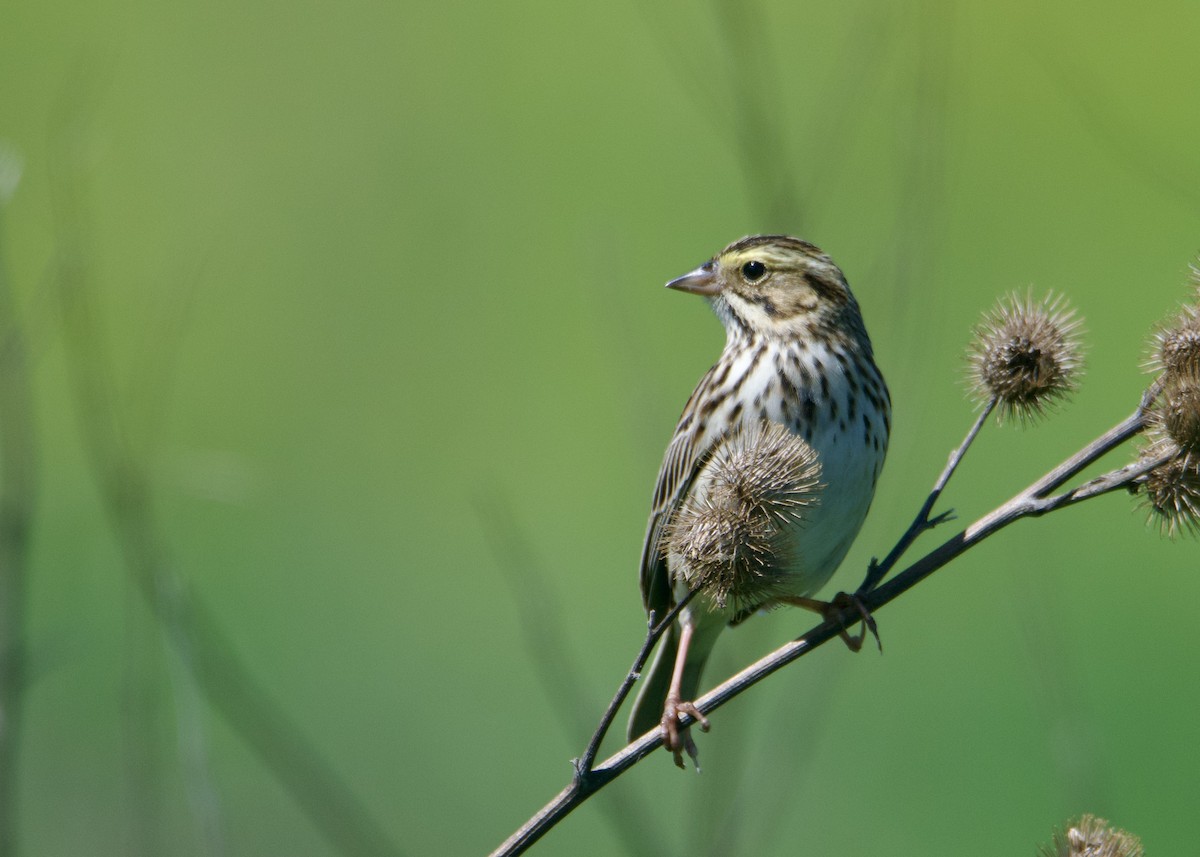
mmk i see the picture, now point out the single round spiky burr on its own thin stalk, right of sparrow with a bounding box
[970,294,1082,421]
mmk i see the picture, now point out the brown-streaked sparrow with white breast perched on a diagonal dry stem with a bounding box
[629,235,892,767]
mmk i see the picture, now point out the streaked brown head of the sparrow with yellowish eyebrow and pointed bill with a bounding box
[667,235,863,340]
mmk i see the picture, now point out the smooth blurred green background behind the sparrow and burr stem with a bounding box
[0,0,1200,857]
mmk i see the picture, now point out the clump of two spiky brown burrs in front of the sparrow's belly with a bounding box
[665,421,821,610]
